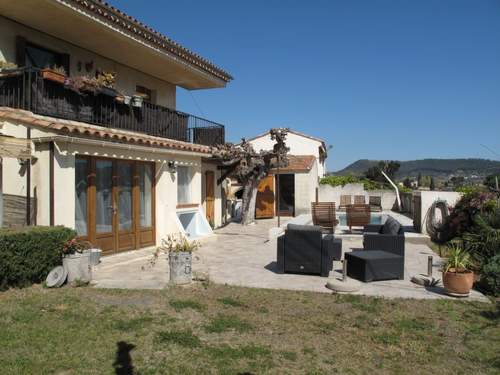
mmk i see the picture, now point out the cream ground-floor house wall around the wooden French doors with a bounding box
[0,118,222,244]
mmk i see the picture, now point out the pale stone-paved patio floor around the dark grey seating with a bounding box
[93,219,488,301]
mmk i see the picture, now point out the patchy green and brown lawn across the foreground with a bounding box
[0,285,500,374]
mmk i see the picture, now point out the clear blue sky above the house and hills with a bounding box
[111,0,500,170]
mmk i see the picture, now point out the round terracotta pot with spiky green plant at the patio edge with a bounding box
[443,244,474,296]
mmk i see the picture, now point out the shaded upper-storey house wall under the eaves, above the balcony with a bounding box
[0,16,176,109]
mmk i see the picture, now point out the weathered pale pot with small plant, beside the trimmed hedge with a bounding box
[62,238,92,283]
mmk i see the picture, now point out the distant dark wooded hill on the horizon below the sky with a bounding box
[333,159,500,178]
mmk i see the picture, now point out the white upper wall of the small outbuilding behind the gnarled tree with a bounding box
[249,132,325,178]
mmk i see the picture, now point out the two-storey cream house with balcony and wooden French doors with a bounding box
[0,0,232,253]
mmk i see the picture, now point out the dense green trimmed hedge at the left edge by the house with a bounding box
[0,227,76,290]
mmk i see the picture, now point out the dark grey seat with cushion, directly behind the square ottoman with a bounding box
[363,216,405,257]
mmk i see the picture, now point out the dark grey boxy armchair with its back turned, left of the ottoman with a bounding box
[276,224,342,277]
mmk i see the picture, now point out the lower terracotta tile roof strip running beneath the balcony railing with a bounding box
[0,107,212,154]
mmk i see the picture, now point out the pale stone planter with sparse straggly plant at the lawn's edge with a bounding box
[150,233,201,285]
